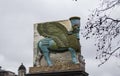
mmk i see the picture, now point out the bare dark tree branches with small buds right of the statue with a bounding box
[82,0,120,66]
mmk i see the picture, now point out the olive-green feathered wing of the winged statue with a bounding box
[37,22,69,47]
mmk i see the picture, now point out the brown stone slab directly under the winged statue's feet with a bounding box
[29,64,85,73]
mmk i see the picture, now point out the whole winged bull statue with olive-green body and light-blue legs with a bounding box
[37,18,80,66]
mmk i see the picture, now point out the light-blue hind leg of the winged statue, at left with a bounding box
[40,46,52,66]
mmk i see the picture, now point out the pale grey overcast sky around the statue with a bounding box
[0,0,120,76]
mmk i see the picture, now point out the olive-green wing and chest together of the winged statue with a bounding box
[37,22,80,51]
